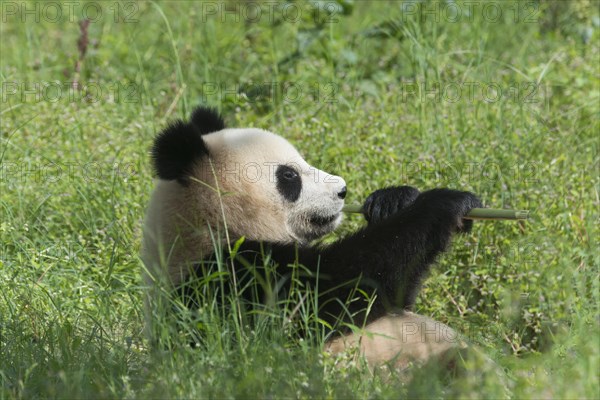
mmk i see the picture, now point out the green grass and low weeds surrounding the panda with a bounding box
[0,0,600,398]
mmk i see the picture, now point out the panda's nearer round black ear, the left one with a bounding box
[152,121,208,185]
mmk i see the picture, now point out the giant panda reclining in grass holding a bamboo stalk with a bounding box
[141,107,481,368]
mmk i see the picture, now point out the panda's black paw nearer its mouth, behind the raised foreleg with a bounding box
[363,186,419,224]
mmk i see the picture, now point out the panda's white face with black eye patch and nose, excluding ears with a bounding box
[204,129,346,243]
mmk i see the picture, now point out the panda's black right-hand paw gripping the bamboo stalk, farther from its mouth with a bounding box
[415,189,483,233]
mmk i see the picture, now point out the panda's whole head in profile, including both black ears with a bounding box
[152,108,346,243]
